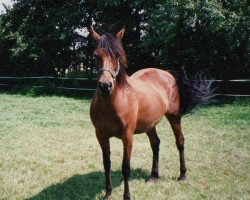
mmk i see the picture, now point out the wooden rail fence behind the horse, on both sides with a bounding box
[0,76,250,97]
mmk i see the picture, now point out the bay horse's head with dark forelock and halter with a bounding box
[91,27,127,96]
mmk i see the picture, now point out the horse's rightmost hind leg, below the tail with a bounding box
[166,114,186,181]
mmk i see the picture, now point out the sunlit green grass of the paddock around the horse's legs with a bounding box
[0,94,250,200]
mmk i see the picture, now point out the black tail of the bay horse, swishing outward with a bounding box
[176,71,215,114]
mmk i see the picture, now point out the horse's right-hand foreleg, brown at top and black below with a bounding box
[122,134,133,200]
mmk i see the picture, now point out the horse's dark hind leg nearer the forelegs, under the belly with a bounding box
[146,127,160,182]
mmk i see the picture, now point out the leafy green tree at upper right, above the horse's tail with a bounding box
[142,0,250,78]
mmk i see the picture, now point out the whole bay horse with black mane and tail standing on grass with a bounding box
[90,28,212,200]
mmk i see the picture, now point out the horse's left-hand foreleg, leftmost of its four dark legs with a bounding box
[97,134,112,199]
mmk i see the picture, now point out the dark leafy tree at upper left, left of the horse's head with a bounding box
[1,0,92,75]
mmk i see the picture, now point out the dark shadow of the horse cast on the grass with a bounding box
[28,169,149,200]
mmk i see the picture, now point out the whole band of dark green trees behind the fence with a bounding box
[0,0,250,79]
